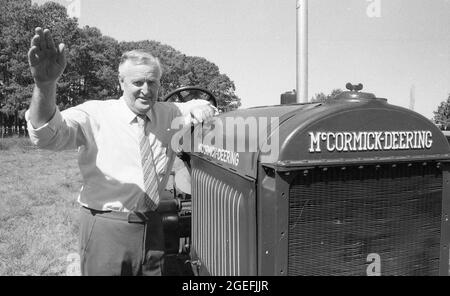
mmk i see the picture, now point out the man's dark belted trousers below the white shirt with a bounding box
[80,207,164,276]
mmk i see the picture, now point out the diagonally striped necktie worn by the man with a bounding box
[137,115,159,212]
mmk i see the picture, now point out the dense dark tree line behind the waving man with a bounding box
[0,0,241,136]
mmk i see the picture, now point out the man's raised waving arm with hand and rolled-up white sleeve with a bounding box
[25,27,88,150]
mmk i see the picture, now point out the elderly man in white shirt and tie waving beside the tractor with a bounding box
[26,28,215,275]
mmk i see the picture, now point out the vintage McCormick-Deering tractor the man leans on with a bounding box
[159,85,450,276]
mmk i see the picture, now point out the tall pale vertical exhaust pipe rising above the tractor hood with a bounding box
[297,0,309,103]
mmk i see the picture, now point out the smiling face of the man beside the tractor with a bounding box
[119,61,161,114]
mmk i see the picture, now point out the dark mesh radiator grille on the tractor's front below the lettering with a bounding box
[288,164,442,276]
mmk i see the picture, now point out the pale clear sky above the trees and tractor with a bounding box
[35,0,450,118]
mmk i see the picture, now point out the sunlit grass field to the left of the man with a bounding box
[0,138,81,275]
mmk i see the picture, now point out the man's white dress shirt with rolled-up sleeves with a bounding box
[25,98,200,212]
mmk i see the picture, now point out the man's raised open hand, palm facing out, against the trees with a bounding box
[28,27,67,83]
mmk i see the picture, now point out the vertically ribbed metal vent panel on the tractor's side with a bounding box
[192,169,246,276]
